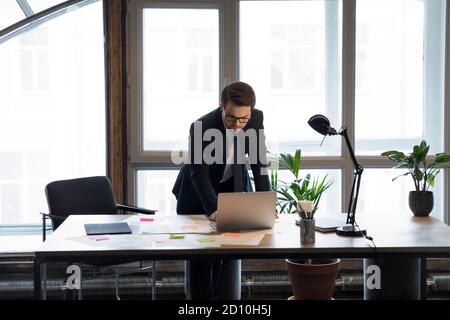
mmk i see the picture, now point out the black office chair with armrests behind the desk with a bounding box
[41,176,156,299]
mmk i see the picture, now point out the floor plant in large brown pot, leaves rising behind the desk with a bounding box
[271,149,340,300]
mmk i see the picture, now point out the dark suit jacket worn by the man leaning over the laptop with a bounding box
[172,108,270,215]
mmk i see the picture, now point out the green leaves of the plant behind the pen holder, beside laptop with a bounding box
[270,149,333,213]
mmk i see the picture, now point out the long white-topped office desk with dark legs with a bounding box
[34,215,450,299]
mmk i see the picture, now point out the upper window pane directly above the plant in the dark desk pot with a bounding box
[355,0,445,155]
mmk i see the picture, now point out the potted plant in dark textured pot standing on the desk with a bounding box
[381,140,450,216]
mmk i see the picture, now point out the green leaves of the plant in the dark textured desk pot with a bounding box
[381,140,450,192]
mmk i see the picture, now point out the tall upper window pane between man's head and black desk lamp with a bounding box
[239,1,342,155]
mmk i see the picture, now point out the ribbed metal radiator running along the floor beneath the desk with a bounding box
[0,272,450,299]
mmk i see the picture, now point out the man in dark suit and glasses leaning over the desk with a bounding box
[172,82,270,299]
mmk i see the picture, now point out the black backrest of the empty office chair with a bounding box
[45,176,118,229]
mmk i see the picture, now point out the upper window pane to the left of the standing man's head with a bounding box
[141,8,219,151]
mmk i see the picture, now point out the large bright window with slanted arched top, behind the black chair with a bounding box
[0,1,106,224]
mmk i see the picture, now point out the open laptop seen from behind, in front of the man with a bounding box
[216,191,276,231]
